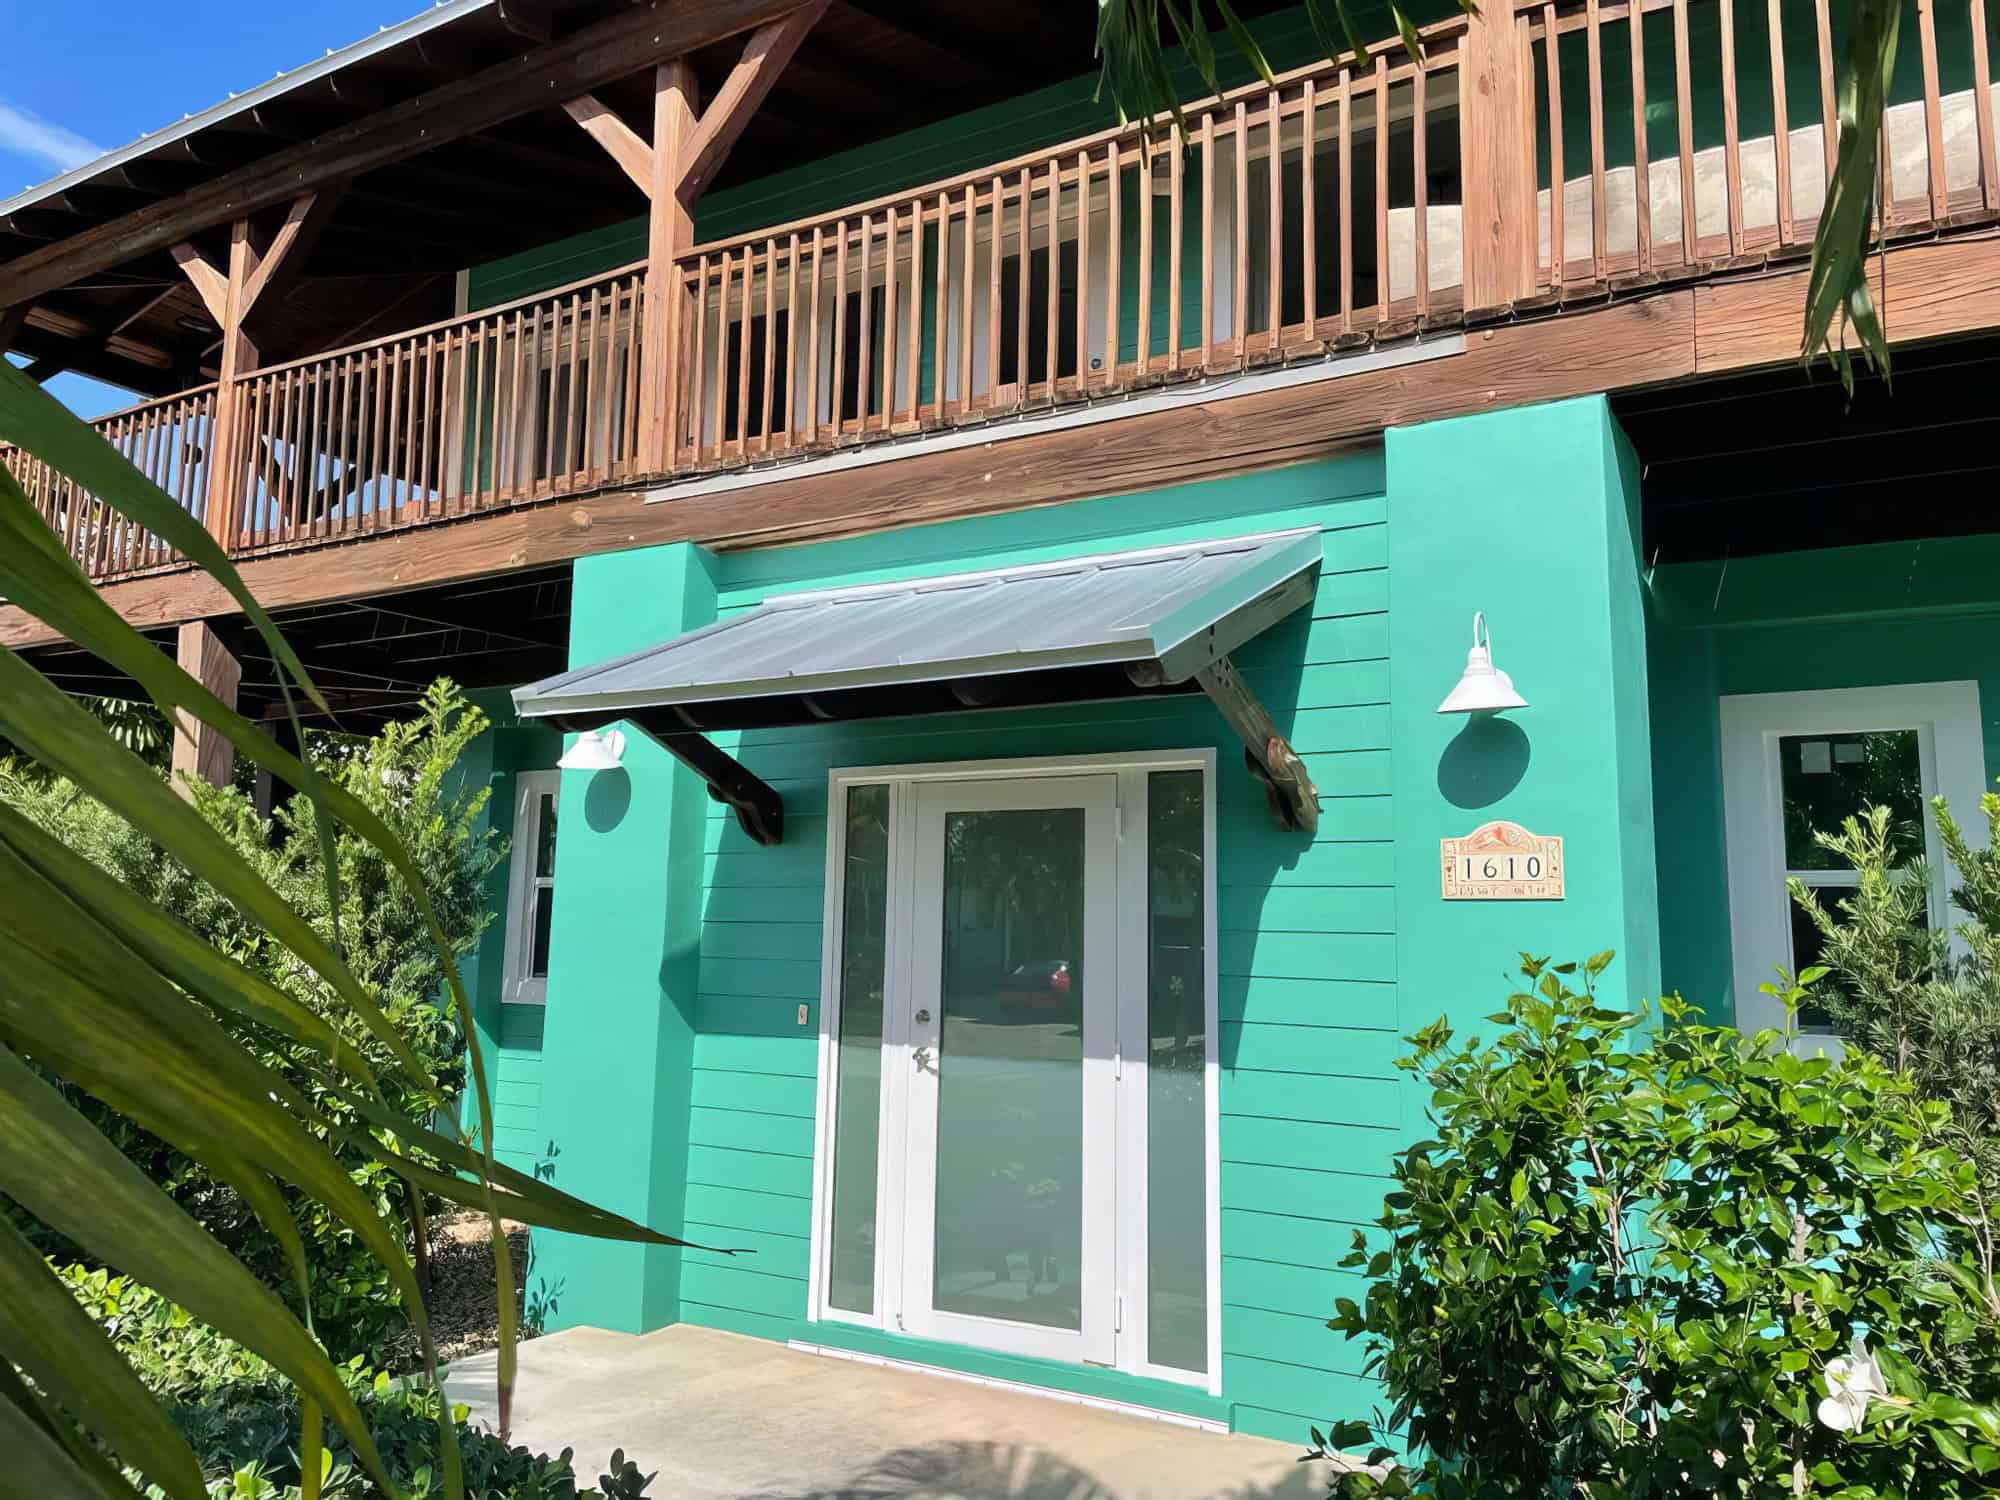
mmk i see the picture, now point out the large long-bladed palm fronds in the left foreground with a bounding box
[0,346,680,1500]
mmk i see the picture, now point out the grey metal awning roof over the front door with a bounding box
[514,526,1320,718]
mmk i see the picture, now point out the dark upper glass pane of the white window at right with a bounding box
[1778,730,1924,870]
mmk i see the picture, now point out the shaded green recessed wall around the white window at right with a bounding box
[1648,536,2000,1020]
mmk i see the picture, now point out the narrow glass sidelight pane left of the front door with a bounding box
[826,786,888,1312]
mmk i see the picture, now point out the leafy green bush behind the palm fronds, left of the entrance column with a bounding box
[0,680,504,1358]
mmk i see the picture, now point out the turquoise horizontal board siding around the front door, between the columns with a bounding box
[682,466,1404,1438]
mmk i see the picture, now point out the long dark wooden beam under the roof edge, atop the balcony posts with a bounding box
[0,0,798,304]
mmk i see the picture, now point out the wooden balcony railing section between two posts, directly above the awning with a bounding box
[674,22,1464,468]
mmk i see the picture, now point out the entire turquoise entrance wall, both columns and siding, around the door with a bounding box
[536,400,1656,1440]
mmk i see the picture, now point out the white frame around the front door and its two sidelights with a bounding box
[806,750,1222,1396]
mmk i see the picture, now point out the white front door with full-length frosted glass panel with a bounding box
[902,774,1118,1364]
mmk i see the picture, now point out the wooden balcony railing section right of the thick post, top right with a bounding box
[1518,0,2000,288]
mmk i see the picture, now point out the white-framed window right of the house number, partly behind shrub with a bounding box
[1722,682,1986,1052]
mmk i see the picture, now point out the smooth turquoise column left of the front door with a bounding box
[528,542,716,1332]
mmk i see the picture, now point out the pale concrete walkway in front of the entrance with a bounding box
[446,1326,1328,1500]
